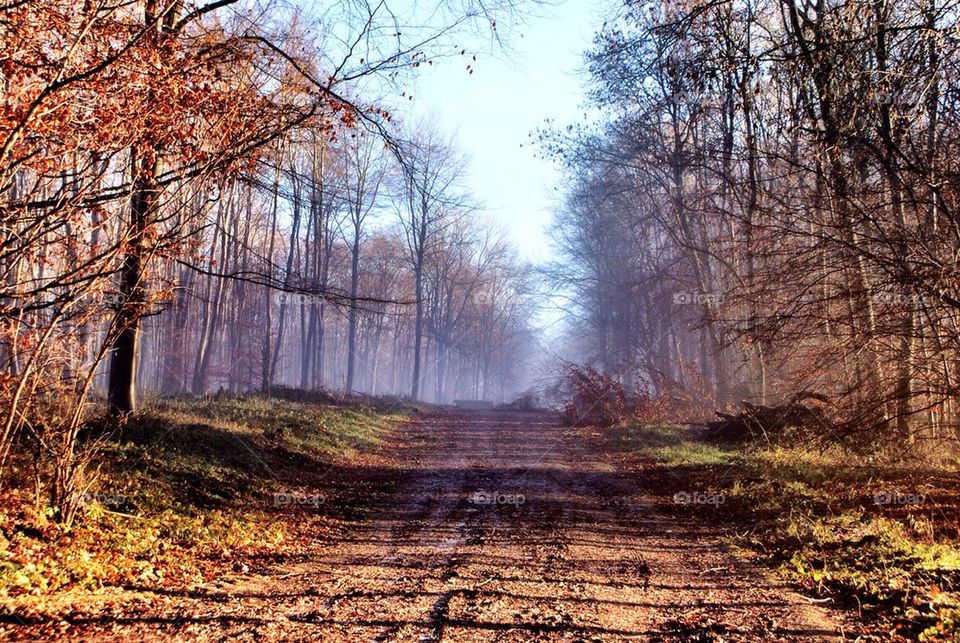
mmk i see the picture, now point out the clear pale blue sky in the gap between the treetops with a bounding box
[410,0,602,262]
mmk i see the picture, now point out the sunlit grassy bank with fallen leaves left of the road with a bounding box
[0,396,404,597]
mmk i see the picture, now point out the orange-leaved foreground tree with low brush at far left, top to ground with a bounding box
[0,1,337,522]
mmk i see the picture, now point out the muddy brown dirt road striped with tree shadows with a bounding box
[11,412,839,641]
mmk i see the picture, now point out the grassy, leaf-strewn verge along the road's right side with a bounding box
[612,424,960,640]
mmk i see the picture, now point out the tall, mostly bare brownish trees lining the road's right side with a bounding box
[544,0,960,446]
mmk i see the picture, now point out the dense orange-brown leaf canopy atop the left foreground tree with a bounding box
[0,0,314,181]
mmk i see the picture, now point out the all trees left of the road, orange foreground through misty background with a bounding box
[0,0,527,525]
